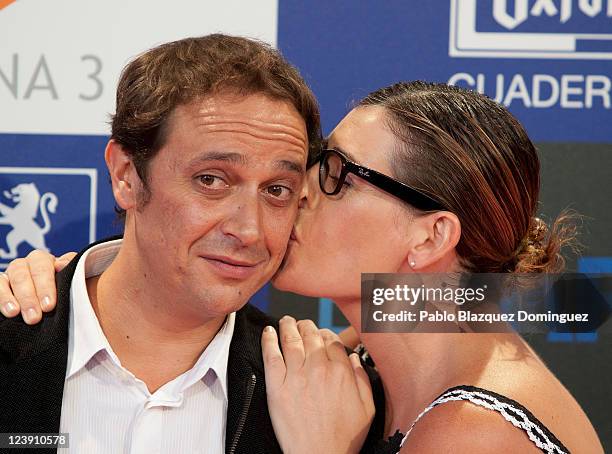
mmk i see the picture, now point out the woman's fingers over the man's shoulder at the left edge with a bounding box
[0,250,76,325]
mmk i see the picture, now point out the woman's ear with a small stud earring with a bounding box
[406,211,461,271]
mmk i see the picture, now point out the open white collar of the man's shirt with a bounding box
[66,240,236,399]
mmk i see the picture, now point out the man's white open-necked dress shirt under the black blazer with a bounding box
[60,240,235,454]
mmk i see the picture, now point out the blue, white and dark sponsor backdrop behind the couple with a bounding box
[0,0,612,446]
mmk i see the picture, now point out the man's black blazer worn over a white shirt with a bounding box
[0,239,384,454]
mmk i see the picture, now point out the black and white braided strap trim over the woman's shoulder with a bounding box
[397,385,569,454]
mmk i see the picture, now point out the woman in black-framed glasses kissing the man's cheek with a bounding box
[0,82,603,453]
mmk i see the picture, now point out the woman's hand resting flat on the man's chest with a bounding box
[261,316,375,454]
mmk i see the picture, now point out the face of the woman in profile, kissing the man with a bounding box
[273,106,412,301]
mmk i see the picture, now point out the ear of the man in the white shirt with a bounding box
[104,140,141,210]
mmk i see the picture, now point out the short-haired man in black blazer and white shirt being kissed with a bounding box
[0,35,382,453]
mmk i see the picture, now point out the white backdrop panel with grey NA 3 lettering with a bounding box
[0,0,278,135]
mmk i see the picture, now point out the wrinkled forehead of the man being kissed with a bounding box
[150,95,308,173]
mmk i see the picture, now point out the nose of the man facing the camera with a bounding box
[221,194,262,246]
